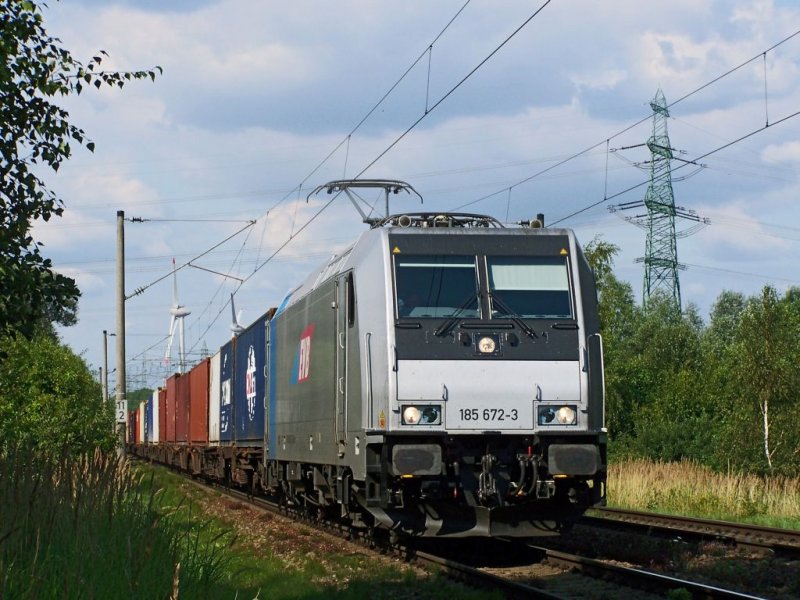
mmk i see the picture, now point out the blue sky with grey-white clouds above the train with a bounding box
[34,0,800,389]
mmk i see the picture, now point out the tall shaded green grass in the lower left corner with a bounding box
[0,452,231,599]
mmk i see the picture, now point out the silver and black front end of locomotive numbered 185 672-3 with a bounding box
[363,221,606,537]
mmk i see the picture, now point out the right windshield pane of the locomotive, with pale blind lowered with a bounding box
[486,256,572,319]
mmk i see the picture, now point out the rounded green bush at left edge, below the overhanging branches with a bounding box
[0,334,115,455]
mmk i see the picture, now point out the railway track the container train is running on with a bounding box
[150,464,776,600]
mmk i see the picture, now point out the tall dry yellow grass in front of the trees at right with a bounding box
[608,459,800,528]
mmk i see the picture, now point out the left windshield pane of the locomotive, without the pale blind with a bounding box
[395,254,480,318]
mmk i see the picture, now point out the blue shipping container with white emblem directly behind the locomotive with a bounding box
[233,315,267,446]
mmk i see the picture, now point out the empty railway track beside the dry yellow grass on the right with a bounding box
[581,508,800,559]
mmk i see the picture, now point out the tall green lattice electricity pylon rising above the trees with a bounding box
[609,88,709,310]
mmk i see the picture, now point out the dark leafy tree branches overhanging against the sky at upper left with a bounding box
[0,0,161,338]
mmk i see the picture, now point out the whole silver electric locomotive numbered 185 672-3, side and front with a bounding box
[262,182,606,537]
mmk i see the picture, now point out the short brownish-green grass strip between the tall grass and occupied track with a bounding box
[137,465,501,600]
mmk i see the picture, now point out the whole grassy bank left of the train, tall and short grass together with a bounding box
[0,454,498,600]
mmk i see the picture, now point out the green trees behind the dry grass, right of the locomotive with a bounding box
[585,239,800,474]
